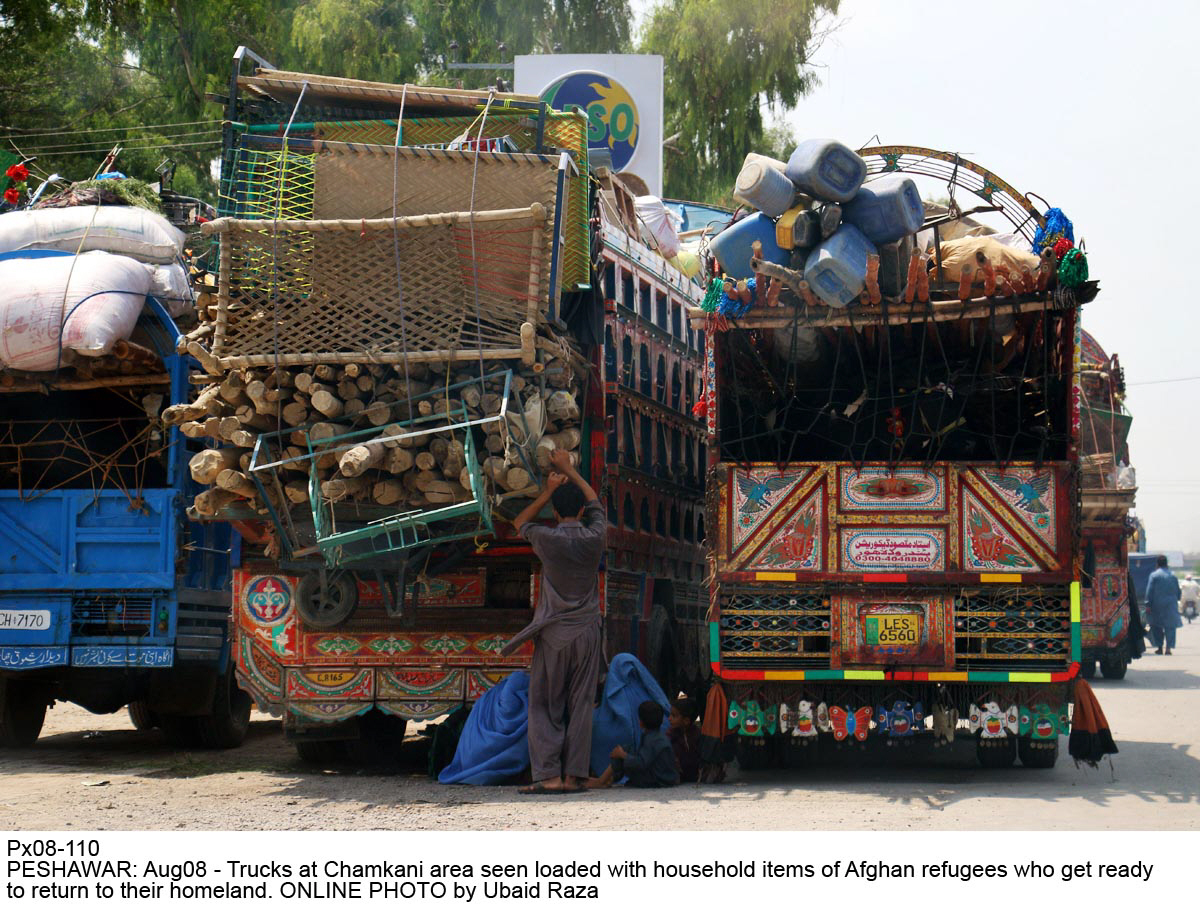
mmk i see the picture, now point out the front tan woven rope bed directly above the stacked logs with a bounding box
[205,204,548,370]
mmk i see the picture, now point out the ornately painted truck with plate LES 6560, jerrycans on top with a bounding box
[690,146,1097,767]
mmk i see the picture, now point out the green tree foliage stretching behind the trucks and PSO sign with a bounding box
[0,0,838,203]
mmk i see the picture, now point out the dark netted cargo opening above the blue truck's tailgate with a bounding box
[0,389,167,504]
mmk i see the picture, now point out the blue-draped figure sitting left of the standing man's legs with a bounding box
[438,671,529,785]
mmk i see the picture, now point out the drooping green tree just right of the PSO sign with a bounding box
[638,0,839,202]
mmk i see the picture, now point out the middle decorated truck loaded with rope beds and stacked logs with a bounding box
[180,49,707,761]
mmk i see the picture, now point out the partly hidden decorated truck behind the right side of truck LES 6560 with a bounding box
[1080,331,1142,679]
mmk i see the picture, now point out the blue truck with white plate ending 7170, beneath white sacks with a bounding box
[0,253,251,748]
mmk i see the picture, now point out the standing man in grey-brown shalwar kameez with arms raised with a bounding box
[502,450,608,793]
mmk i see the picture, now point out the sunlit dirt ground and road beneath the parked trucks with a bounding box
[0,623,1200,829]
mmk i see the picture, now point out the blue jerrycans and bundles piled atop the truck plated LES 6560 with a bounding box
[708,139,1097,318]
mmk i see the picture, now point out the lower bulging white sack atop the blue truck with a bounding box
[0,251,150,371]
